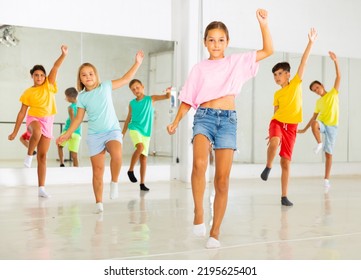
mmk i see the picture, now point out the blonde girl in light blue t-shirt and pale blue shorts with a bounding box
[56,51,144,213]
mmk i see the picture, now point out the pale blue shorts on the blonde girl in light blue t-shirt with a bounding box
[86,130,123,157]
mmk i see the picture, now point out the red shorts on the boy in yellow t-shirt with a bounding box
[268,120,298,160]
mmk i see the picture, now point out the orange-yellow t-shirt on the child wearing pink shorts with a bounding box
[20,78,58,117]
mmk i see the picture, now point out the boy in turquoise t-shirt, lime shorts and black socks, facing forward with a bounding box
[123,79,171,191]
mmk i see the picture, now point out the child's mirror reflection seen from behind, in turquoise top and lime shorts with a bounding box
[58,87,81,167]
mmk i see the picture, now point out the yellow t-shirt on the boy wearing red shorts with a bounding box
[272,74,302,124]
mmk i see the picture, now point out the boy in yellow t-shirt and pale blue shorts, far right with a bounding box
[298,52,341,192]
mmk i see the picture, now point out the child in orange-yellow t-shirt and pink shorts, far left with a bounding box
[8,45,68,198]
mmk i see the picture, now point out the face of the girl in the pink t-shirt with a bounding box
[204,28,228,60]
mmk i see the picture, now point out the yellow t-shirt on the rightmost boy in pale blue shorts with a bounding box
[315,88,339,126]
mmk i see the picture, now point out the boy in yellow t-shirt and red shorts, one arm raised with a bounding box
[261,28,317,206]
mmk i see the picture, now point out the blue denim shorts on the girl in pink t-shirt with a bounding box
[192,107,237,150]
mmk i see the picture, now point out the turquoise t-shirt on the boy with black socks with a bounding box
[128,96,154,137]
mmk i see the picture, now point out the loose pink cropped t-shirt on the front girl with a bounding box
[179,51,259,109]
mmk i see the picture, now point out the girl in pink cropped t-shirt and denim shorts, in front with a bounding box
[167,9,273,248]
